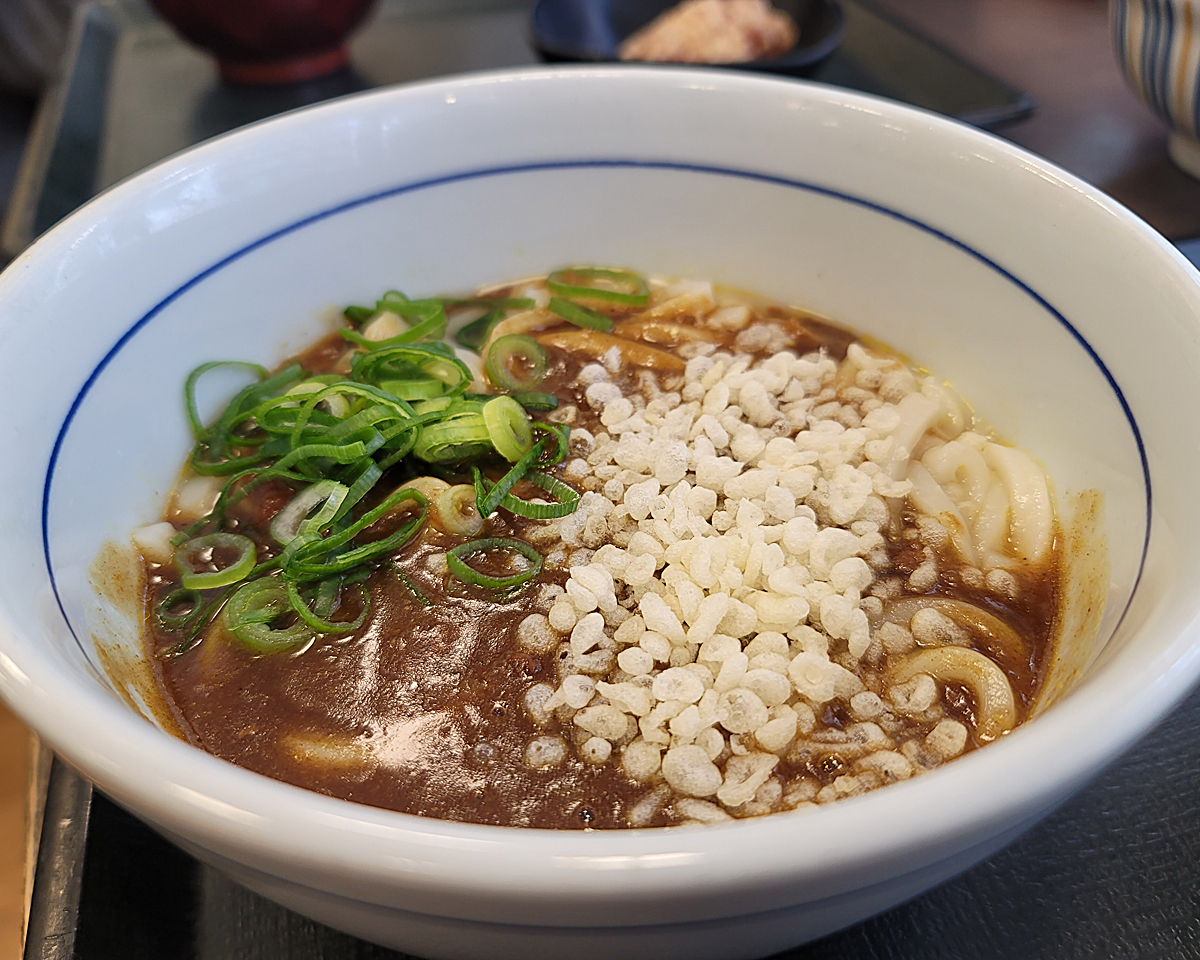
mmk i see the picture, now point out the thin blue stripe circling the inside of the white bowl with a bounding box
[42,160,1152,673]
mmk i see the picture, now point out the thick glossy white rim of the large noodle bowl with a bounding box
[0,66,1200,924]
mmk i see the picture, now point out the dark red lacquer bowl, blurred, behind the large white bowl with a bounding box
[150,0,374,84]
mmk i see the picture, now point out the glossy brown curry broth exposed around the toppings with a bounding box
[146,303,1058,828]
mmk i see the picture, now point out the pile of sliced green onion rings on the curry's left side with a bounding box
[164,279,580,656]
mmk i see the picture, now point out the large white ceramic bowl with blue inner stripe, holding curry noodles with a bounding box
[0,68,1200,960]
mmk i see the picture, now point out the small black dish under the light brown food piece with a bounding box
[533,0,846,77]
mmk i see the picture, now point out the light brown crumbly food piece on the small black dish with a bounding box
[618,0,799,64]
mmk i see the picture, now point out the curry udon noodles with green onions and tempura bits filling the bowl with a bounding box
[134,268,1060,828]
